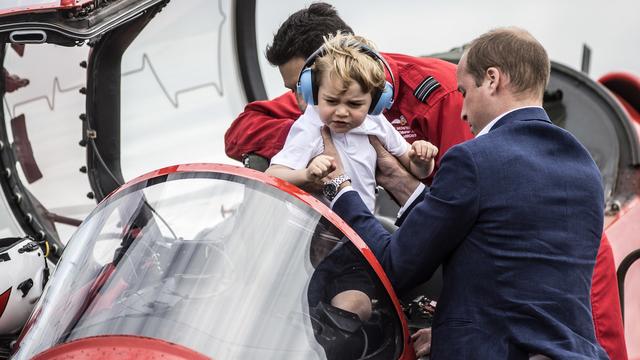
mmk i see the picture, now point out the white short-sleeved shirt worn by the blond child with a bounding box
[271,106,410,212]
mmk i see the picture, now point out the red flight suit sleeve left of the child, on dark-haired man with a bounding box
[224,92,302,161]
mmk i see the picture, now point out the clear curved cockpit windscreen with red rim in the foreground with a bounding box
[14,166,403,359]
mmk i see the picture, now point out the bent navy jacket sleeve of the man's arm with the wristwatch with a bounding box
[332,148,480,291]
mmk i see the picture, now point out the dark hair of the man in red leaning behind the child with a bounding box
[266,2,353,66]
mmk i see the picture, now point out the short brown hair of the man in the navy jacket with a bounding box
[466,27,551,98]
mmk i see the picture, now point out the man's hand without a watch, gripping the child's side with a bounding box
[369,135,420,206]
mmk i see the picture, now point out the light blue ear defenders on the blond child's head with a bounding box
[297,43,395,115]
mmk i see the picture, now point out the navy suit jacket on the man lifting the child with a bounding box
[333,108,607,360]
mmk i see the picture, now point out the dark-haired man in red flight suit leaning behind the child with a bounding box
[225,3,472,183]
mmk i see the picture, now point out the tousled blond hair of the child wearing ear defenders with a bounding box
[312,32,386,94]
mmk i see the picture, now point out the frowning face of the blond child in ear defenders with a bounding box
[318,72,371,133]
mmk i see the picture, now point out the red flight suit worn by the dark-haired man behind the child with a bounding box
[224,53,627,360]
